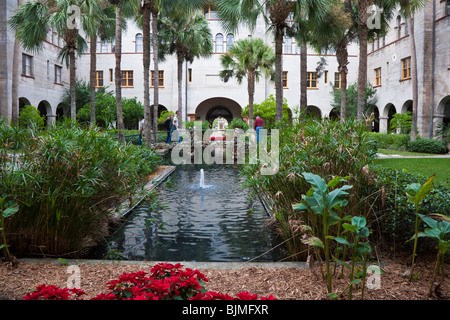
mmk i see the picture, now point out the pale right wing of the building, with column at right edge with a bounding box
[367,0,450,138]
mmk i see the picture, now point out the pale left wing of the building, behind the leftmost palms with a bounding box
[0,0,69,122]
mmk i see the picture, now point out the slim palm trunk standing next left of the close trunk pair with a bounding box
[115,5,125,141]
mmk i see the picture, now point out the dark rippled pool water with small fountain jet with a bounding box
[101,165,283,262]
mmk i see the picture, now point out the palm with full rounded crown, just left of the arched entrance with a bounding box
[159,10,213,127]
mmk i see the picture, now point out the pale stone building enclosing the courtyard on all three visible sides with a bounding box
[0,0,450,137]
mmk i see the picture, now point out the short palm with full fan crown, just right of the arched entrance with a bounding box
[220,39,275,128]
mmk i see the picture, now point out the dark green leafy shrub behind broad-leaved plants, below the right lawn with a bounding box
[372,166,450,250]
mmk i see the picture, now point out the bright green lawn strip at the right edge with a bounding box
[375,158,450,187]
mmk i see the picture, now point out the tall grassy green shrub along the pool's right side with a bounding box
[242,119,377,260]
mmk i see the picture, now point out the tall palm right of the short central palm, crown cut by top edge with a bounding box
[216,0,328,122]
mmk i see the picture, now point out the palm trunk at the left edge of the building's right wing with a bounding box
[357,0,371,120]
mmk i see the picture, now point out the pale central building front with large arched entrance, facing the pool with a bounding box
[78,7,358,126]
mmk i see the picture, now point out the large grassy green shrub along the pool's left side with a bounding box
[0,122,158,256]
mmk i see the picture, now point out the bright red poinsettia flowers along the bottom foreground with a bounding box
[23,263,275,300]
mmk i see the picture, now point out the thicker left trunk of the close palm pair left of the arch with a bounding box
[142,1,151,146]
